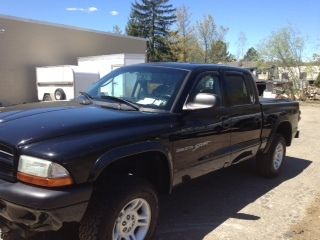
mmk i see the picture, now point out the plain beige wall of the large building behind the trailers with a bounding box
[0,16,146,105]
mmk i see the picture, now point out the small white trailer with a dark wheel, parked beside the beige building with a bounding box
[36,65,100,101]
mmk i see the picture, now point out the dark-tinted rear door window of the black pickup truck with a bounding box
[225,74,252,106]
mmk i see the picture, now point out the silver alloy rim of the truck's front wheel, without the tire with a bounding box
[112,198,151,240]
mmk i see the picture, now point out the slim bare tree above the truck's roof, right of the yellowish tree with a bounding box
[197,15,216,63]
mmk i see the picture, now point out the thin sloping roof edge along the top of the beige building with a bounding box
[0,14,147,42]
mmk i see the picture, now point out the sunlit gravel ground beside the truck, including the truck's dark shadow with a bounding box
[2,104,320,240]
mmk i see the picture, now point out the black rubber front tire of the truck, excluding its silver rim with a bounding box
[79,177,159,240]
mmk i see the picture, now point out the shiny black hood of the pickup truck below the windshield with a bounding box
[0,101,168,147]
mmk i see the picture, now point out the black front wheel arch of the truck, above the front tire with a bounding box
[89,142,173,193]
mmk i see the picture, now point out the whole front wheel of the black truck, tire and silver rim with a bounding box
[79,179,158,240]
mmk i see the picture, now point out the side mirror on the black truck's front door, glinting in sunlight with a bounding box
[183,93,219,110]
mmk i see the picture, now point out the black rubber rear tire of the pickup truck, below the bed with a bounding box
[256,134,286,178]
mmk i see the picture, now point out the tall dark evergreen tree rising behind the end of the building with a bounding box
[126,0,176,61]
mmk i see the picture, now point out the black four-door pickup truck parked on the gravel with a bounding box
[0,63,300,240]
